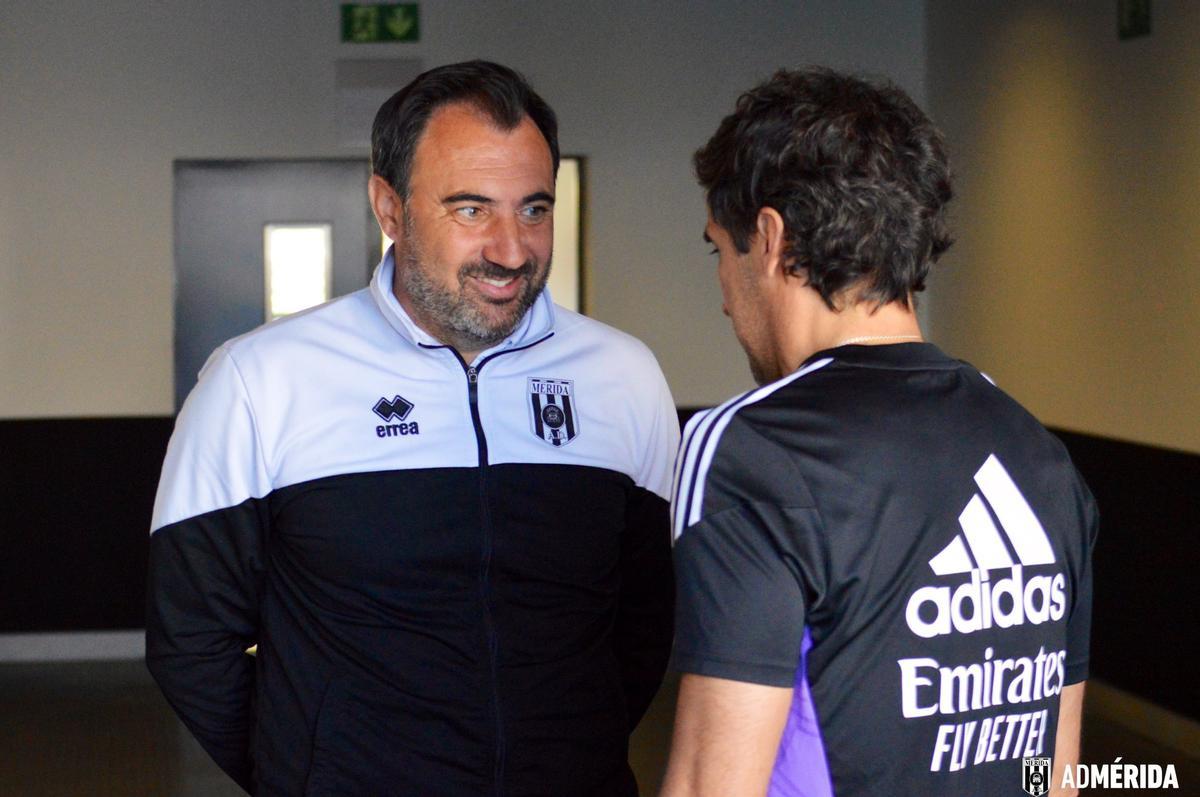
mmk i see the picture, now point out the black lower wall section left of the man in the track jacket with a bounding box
[0,418,174,633]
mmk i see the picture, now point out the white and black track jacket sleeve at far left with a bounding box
[146,349,269,792]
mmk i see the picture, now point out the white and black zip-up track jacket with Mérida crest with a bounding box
[146,252,679,796]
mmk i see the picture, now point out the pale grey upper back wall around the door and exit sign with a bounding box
[0,0,925,418]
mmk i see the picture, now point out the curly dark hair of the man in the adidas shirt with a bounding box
[695,68,953,307]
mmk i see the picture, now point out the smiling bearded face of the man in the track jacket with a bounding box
[395,104,554,356]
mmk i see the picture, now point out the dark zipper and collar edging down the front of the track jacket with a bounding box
[436,332,554,797]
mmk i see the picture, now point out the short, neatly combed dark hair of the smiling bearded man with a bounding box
[371,61,558,198]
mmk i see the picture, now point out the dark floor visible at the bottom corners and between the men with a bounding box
[0,661,1200,797]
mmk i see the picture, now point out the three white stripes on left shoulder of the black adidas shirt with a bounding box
[671,356,833,539]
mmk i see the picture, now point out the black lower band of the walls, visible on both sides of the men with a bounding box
[0,417,1200,719]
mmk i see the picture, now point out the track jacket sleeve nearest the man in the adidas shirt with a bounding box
[616,364,679,731]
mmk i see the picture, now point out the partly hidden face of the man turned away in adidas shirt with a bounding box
[704,215,784,384]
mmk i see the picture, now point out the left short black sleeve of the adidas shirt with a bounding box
[672,412,820,687]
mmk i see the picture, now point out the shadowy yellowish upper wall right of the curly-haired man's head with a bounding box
[928,0,1200,451]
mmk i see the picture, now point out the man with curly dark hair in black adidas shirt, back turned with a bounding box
[664,68,1097,797]
